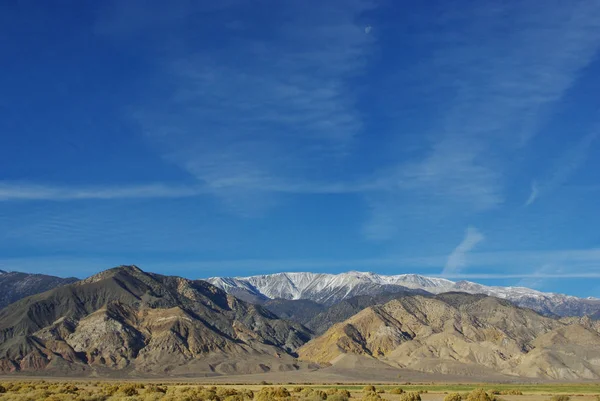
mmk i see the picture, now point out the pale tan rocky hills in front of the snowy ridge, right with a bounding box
[298,293,600,380]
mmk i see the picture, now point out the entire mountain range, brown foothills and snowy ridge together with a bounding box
[0,266,600,381]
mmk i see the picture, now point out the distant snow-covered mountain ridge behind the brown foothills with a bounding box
[208,272,600,316]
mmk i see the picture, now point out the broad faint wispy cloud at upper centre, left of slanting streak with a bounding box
[129,1,373,216]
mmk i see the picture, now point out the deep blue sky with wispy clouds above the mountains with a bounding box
[0,0,600,296]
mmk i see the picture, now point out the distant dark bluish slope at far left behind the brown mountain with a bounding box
[0,270,78,309]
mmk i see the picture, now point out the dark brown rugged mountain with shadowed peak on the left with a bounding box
[0,266,310,374]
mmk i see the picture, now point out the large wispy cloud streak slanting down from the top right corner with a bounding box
[366,1,600,238]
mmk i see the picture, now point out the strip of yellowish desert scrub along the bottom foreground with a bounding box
[0,380,600,401]
